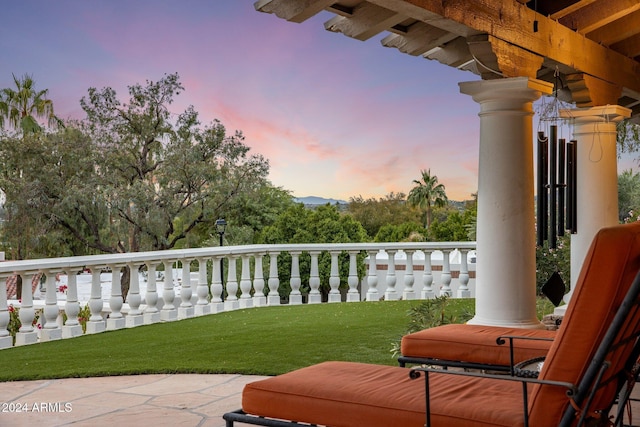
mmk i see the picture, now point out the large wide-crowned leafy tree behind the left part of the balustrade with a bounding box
[0,74,288,297]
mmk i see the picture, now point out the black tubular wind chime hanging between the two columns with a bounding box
[536,70,577,249]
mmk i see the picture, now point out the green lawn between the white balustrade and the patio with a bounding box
[0,299,474,381]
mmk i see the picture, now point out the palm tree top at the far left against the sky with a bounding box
[0,74,62,134]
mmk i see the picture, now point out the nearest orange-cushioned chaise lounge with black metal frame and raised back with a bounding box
[224,224,640,427]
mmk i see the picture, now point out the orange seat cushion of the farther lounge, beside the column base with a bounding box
[401,325,556,366]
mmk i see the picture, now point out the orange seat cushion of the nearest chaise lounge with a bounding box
[242,362,523,427]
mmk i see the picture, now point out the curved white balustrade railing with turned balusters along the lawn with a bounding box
[0,242,476,348]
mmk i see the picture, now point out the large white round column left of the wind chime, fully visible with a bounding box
[460,77,553,328]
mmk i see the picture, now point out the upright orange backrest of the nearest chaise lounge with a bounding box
[529,222,640,426]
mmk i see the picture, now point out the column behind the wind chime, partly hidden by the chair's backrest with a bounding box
[554,105,631,315]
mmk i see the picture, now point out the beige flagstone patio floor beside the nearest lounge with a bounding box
[0,374,640,427]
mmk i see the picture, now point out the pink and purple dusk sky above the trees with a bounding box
[0,0,628,200]
